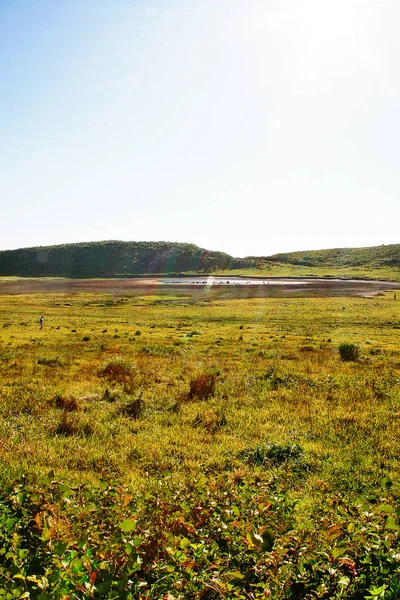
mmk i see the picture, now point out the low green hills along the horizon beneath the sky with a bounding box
[0,241,400,278]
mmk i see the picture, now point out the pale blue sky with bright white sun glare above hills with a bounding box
[0,0,400,257]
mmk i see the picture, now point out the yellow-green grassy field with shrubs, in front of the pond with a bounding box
[0,288,400,600]
